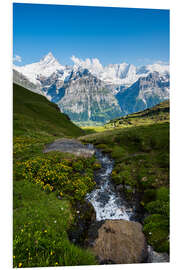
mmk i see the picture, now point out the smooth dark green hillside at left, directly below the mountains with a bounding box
[13,84,83,137]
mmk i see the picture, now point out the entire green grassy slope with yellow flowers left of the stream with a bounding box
[13,85,96,268]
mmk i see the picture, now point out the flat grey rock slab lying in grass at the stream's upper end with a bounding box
[43,138,95,157]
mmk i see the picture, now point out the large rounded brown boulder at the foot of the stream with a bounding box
[92,220,147,264]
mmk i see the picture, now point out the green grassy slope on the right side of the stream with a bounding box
[81,102,169,252]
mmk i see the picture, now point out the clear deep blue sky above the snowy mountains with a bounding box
[13,3,169,65]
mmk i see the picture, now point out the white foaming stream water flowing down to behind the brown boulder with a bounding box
[86,145,134,221]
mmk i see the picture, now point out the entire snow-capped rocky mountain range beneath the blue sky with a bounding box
[13,53,170,124]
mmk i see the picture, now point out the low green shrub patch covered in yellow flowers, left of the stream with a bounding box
[16,154,96,200]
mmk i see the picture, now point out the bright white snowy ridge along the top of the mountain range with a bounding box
[13,52,169,87]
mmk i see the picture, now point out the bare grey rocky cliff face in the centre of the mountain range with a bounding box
[57,69,121,122]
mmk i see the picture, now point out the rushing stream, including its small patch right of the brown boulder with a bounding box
[86,144,169,263]
